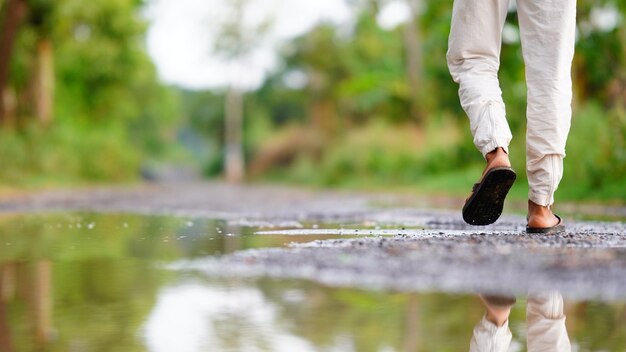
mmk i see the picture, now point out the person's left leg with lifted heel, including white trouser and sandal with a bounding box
[447,0,516,225]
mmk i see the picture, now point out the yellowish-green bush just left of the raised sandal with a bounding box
[275,119,464,187]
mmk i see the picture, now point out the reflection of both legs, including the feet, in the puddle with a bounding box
[470,291,572,352]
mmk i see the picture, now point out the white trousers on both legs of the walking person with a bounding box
[447,0,576,206]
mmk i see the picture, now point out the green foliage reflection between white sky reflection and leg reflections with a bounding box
[258,280,483,351]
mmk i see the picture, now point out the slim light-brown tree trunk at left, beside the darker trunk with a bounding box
[35,39,54,126]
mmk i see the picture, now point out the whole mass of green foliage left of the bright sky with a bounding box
[0,0,180,186]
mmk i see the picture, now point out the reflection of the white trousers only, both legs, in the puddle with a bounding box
[470,292,571,352]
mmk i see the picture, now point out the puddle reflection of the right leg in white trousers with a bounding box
[526,292,571,352]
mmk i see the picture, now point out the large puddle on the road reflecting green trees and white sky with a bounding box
[0,214,626,352]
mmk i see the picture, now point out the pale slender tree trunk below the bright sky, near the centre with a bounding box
[224,87,245,183]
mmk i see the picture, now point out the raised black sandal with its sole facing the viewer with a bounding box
[463,167,517,226]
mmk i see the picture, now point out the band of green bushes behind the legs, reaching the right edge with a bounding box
[260,104,626,202]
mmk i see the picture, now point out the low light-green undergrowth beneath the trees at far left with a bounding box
[0,124,142,186]
